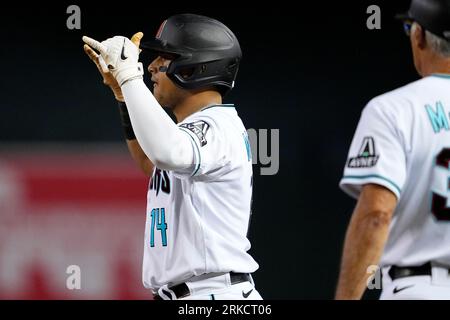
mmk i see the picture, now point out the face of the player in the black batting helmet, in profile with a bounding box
[148,55,184,109]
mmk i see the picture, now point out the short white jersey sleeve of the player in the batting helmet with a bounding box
[173,116,229,179]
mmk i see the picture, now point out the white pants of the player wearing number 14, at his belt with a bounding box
[158,273,262,300]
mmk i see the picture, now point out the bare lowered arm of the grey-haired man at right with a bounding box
[335,184,397,300]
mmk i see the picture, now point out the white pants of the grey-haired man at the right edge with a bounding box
[380,266,450,300]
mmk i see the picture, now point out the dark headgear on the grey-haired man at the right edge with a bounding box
[396,0,450,40]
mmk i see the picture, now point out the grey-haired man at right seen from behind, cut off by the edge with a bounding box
[336,0,450,299]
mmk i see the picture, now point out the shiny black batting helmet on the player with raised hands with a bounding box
[140,14,242,95]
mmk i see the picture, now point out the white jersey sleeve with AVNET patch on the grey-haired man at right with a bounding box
[339,100,406,199]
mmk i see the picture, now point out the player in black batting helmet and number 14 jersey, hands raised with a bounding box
[83,14,262,300]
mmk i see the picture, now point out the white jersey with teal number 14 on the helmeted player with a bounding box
[143,105,258,292]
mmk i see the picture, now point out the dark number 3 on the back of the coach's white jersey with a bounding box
[431,148,450,221]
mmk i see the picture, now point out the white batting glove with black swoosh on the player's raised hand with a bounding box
[83,36,144,86]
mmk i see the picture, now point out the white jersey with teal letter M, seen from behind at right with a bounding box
[340,75,450,266]
